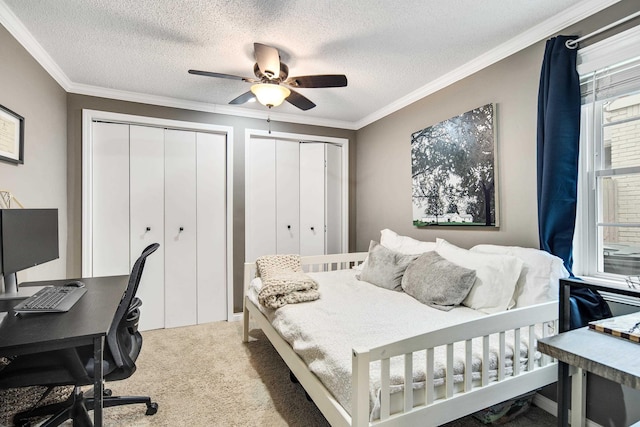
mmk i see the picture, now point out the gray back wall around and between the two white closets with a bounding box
[67,94,356,312]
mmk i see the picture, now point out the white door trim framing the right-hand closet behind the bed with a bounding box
[244,129,349,261]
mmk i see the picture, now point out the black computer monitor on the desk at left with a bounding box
[0,209,59,294]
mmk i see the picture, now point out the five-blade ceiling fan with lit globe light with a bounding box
[189,43,347,111]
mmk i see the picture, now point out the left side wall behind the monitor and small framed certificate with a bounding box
[0,26,68,282]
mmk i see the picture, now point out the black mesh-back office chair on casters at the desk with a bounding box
[0,243,160,427]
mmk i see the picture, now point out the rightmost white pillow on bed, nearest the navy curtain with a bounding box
[471,245,569,307]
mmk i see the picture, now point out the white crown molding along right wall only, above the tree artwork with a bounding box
[355,0,620,129]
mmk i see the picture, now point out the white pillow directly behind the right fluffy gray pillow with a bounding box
[436,239,523,314]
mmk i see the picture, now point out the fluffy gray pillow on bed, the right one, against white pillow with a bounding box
[401,251,476,311]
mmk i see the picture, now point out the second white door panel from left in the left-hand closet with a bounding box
[129,125,165,330]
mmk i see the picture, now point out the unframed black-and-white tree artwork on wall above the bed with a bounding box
[411,104,499,227]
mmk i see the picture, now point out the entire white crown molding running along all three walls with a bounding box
[0,0,620,130]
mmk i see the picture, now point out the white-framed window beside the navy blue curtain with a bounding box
[574,28,640,283]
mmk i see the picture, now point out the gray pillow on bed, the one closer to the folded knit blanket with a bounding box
[358,240,418,291]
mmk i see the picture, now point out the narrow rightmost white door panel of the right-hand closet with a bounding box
[325,144,347,254]
